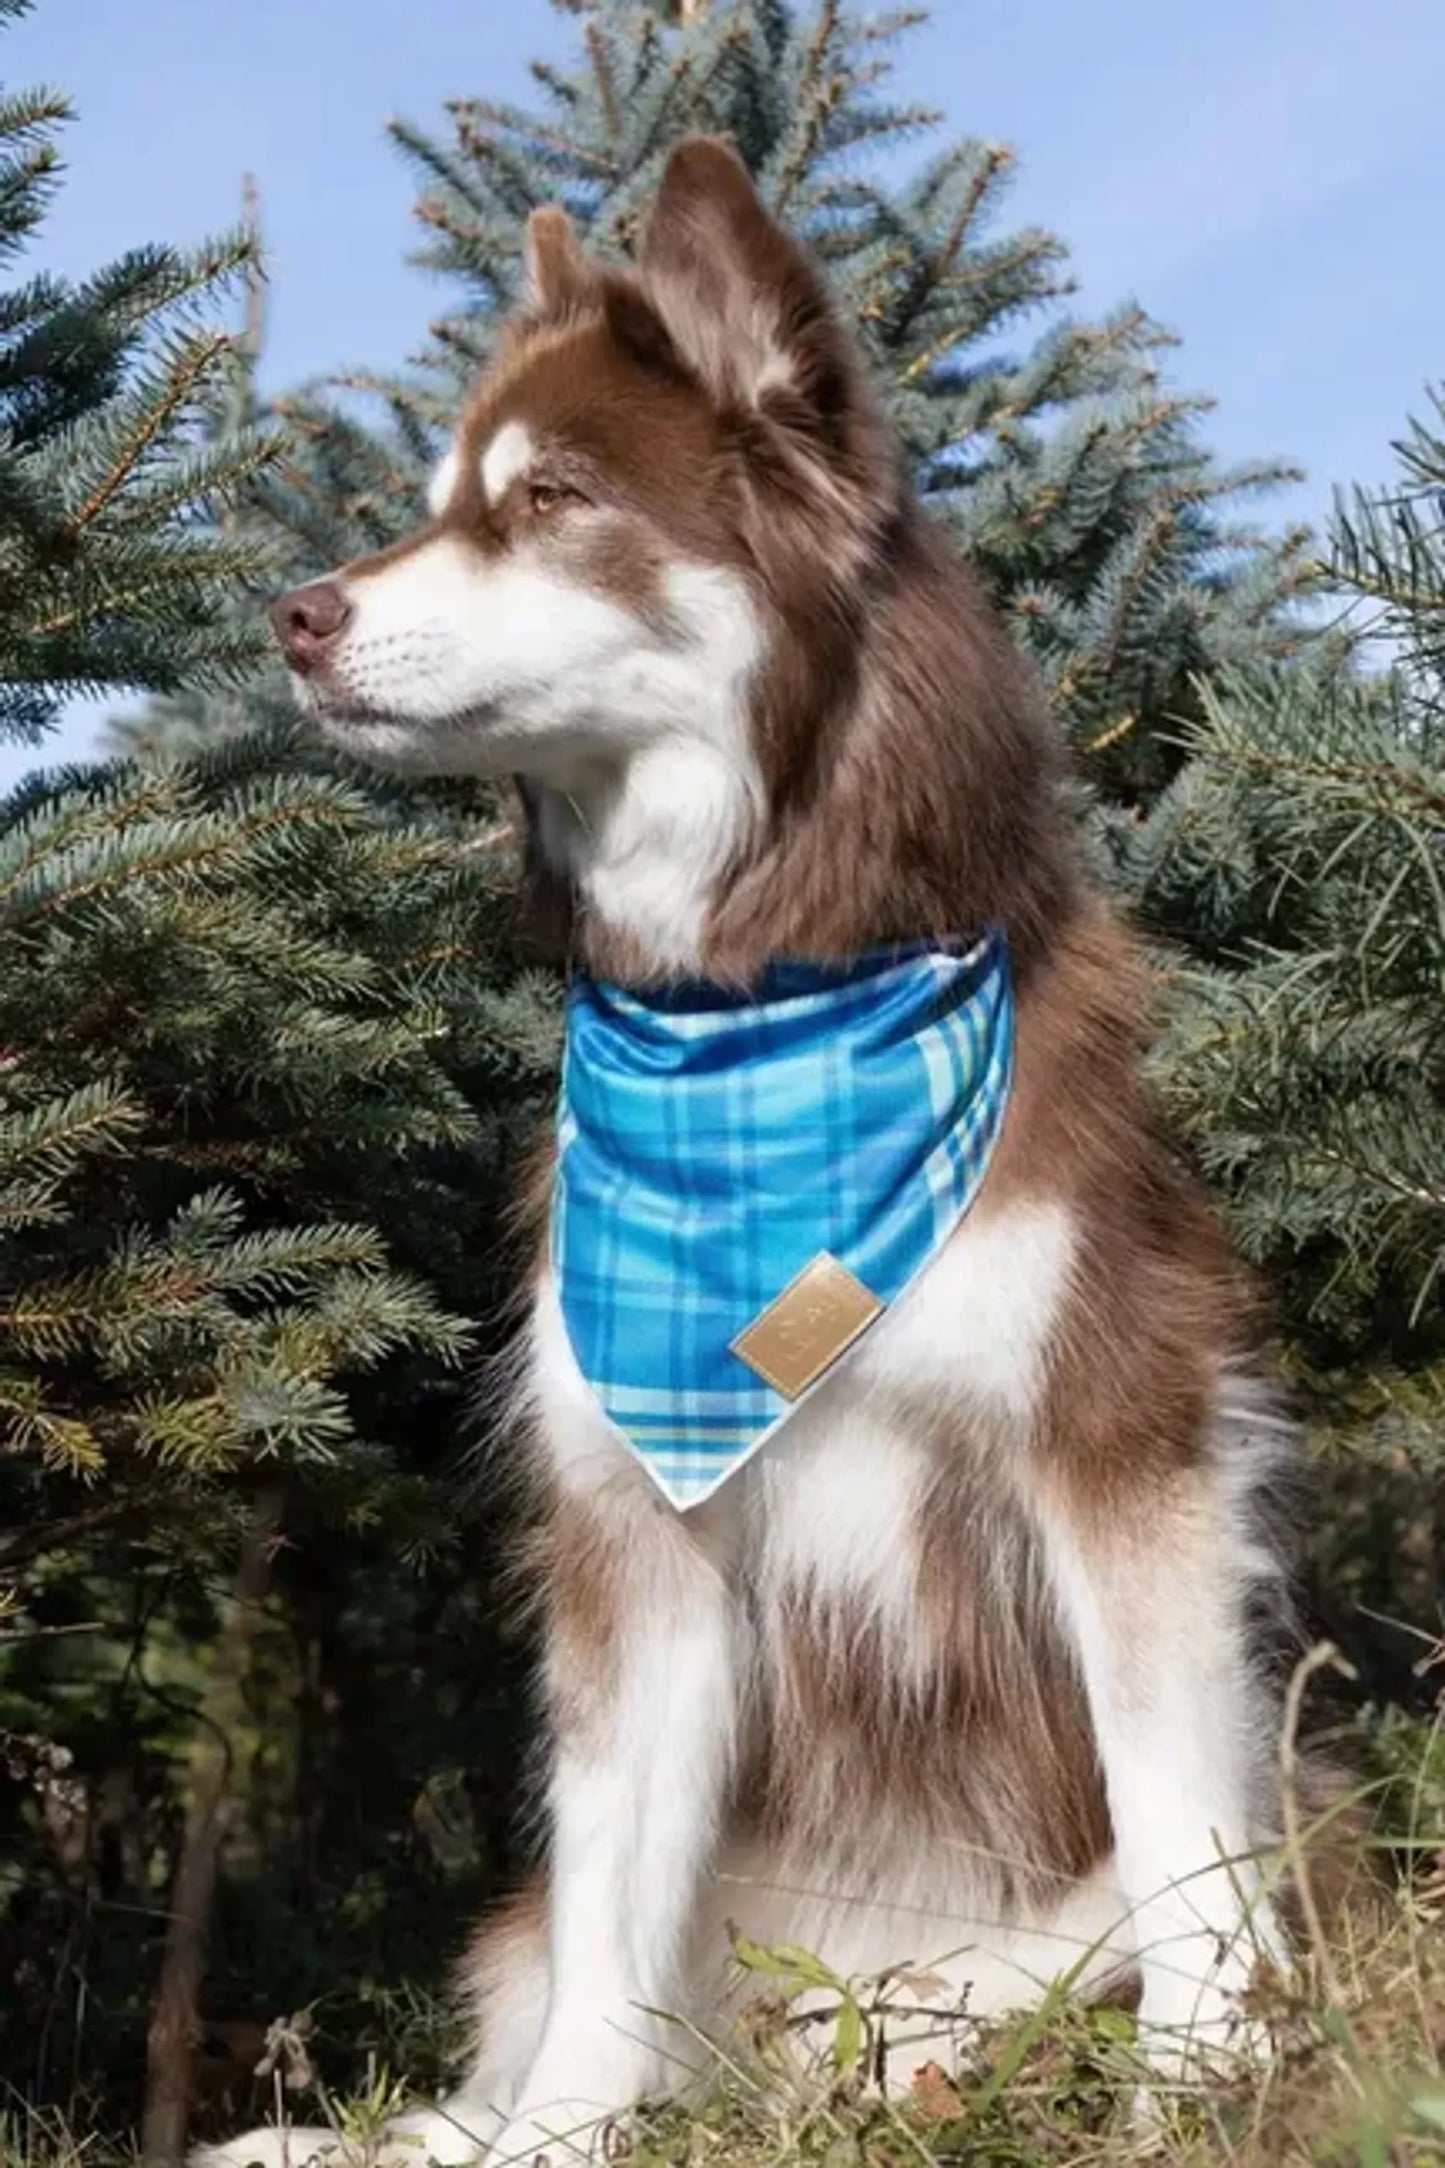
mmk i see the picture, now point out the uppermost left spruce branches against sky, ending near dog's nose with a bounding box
[0,0,277,739]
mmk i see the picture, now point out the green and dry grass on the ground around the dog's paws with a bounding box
[0,1721,1445,2168]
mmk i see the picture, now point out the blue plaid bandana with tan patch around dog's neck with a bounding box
[552,934,1014,1509]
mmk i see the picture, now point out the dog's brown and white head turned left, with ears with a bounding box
[273,139,895,802]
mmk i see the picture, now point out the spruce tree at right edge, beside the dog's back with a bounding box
[1127,392,1445,1702]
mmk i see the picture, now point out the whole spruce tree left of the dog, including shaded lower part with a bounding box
[0,4,555,2124]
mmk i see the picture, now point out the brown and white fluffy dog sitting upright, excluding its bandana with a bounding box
[225,139,1289,2161]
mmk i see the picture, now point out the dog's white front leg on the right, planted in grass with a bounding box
[1040,1468,1278,2073]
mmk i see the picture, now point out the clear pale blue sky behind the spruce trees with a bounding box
[0,0,1445,785]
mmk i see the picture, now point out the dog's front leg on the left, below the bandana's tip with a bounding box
[492,1470,737,2164]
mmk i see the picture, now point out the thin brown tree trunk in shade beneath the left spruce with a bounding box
[141,1492,282,2168]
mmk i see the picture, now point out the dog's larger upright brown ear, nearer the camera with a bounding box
[641,137,856,423]
